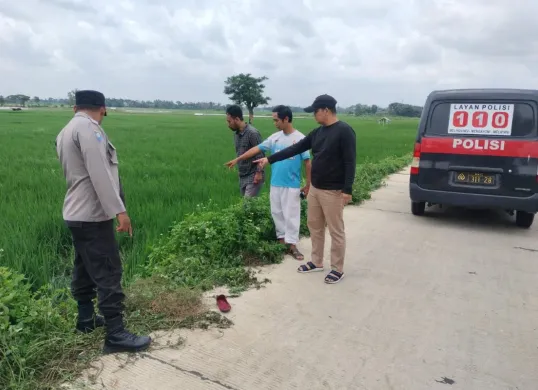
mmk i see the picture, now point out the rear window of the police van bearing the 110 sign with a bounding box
[426,102,536,138]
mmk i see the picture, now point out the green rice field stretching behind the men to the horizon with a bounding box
[0,109,417,287]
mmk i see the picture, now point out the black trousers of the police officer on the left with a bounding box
[67,219,125,319]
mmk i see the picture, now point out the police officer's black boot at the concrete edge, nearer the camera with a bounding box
[103,315,151,353]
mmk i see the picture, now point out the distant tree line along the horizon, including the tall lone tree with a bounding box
[0,73,422,116]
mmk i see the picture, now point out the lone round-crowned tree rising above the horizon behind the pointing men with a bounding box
[224,73,271,123]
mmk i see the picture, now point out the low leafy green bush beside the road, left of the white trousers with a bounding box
[145,194,308,293]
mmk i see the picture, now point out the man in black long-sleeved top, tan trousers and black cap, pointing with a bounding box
[254,95,357,284]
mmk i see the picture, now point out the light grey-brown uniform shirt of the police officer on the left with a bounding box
[56,113,125,222]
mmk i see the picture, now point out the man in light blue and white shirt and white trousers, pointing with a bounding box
[226,105,311,260]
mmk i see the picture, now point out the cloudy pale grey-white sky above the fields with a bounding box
[0,0,538,107]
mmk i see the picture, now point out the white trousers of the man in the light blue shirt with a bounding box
[269,186,301,245]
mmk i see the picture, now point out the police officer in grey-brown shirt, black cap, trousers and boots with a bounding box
[56,90,151,353]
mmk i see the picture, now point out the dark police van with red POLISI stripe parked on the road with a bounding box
[409,89,538,228]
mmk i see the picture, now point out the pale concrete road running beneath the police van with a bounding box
[66,169,538,390]
